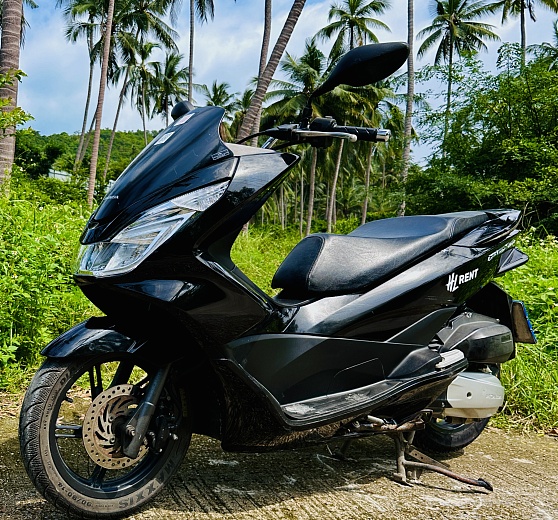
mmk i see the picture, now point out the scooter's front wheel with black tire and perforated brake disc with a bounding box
[19,354,191,519]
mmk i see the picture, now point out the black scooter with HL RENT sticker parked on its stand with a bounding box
[20,43,534,518]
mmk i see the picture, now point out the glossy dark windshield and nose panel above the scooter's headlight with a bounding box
[81,107,236,244]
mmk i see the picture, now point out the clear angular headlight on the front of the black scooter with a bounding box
[76,181,229,277]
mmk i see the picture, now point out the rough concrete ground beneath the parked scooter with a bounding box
[0,410,558,520]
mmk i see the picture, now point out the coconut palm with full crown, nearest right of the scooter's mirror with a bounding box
[417,0,500,151]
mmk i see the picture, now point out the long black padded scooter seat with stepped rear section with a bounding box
[271,211,489,297]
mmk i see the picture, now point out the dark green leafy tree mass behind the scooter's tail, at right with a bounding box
[407,45,558,233]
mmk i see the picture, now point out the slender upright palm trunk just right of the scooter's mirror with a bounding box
[397,0,415,217]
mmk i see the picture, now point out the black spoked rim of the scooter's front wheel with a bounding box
[49,356,181,499]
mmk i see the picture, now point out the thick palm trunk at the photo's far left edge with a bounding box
[0,0,23,186]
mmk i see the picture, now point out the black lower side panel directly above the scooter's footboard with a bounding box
[226,334,450,404]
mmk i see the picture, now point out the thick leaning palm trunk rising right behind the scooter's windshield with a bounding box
[238,0,306,139]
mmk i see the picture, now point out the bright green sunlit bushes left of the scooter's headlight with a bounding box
[0,172,92,386]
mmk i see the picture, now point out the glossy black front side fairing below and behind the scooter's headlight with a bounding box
[76,145,298,348]
